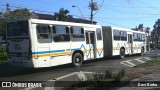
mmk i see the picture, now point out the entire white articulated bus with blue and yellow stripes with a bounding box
[7,19,146,68]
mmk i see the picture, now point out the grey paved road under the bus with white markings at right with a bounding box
[0,54,155,81]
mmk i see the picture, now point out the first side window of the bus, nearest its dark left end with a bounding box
[36,25,51,43]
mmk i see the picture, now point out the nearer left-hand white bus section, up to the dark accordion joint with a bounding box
[7,19,103,68]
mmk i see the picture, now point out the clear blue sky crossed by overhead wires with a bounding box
[0,0,160,30]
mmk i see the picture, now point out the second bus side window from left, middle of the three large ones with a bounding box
[52,26,70,42]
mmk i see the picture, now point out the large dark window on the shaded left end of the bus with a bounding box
[7,21,28,37]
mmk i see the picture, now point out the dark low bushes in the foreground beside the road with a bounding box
[72,69,125,90]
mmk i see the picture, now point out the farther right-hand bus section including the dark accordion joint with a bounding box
[102,26,146,58]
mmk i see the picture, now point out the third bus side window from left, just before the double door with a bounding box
[71,27,85,41]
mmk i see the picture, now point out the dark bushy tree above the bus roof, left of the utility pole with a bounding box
[54,8,73,21]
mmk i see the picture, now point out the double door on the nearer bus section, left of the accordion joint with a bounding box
[85,31,96,59]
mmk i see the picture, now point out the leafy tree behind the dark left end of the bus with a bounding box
[0,8,31,38]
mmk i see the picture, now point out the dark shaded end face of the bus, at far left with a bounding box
[7,20,34,67]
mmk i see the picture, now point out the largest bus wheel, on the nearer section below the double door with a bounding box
[72,53,83,67]
